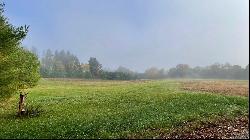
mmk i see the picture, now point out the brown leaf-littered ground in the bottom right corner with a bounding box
[165,116,249,139]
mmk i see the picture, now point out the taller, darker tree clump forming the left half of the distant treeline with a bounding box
[40,50,137,80]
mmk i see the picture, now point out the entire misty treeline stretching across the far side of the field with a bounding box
[40,50,249,80]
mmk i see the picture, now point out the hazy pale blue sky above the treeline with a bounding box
[4,0,249,72]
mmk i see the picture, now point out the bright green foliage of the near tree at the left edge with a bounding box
[0,4,39,97]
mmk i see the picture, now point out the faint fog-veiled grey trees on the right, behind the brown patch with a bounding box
[144,63,249,80]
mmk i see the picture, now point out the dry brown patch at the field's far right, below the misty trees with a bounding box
[181,80,249,97]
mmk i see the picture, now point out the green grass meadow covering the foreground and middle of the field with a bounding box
[0,79,249,138]
